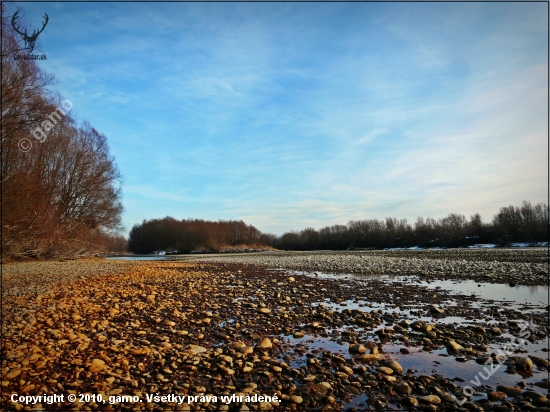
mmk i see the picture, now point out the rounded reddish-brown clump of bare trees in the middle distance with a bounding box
[128,217,266,254]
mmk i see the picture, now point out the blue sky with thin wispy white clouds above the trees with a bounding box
[16,2,549,234]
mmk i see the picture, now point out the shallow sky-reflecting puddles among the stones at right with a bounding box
[281,271,550,409]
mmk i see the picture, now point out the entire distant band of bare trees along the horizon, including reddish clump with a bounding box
[128,201,549,253]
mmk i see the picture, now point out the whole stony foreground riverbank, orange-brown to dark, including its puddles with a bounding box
[2,257,548,411]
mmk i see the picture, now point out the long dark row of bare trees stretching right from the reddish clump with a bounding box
[269,201,549,250]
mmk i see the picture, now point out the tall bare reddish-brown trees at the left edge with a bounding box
[1,3,122,258]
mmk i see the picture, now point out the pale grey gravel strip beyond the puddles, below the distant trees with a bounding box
[180,249,548,285]
